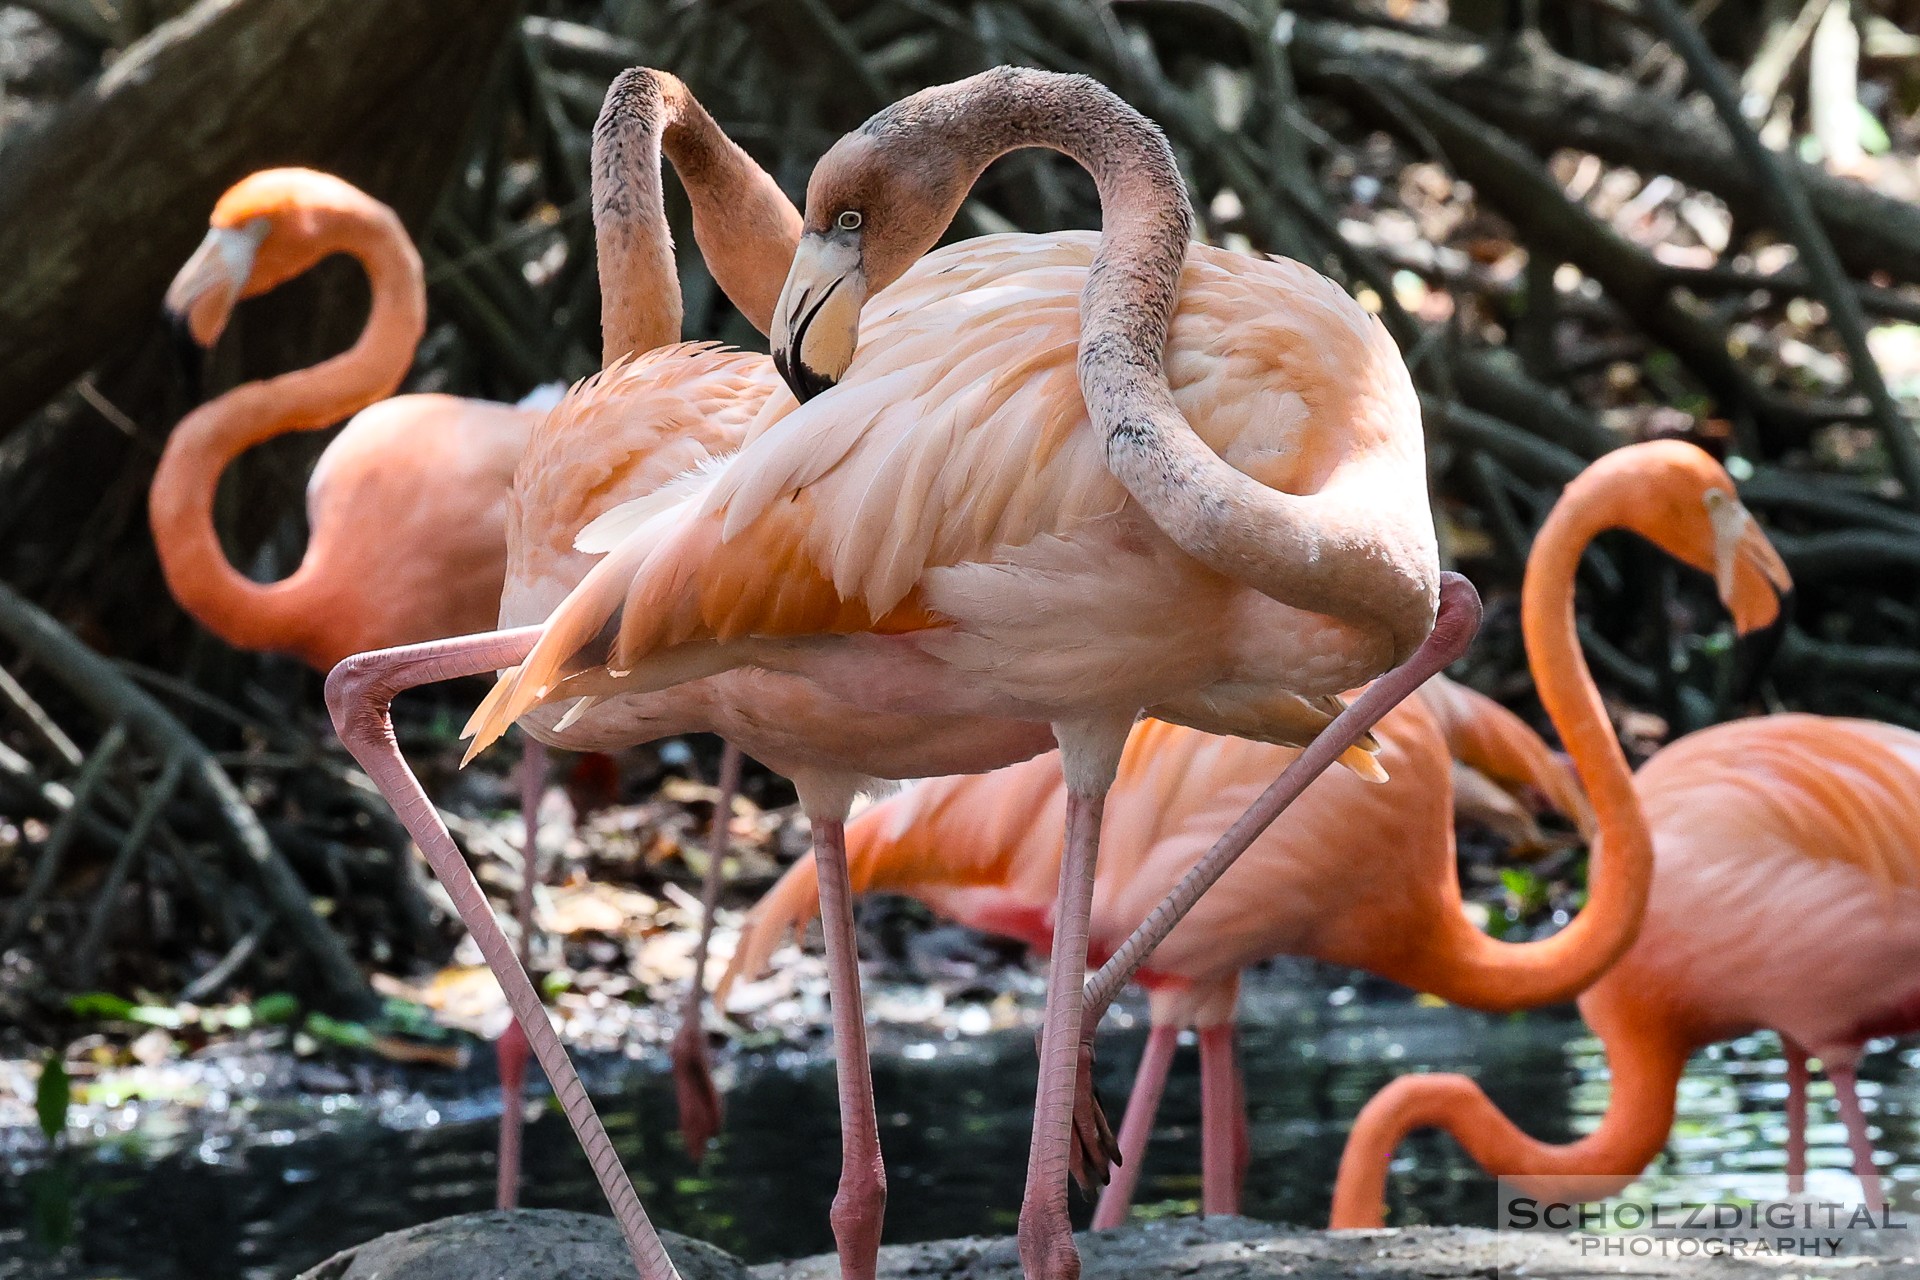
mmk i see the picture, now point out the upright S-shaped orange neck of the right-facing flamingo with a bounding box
[1417,472,1653,1009]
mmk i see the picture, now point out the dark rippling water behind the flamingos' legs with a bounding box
[0,981,1920,1280]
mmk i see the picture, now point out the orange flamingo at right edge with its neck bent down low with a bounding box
[1332,454,1896,1226]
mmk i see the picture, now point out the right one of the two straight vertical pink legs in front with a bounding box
[1020,718,1133,1280]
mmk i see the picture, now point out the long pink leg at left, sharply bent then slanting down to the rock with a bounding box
[326,628,680,1280]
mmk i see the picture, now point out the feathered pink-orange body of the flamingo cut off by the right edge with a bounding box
[1596,714,1920,1054]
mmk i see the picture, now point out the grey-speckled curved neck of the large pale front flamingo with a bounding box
[860,67,1438,664]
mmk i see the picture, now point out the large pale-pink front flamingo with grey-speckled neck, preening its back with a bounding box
[472,69,1473,1280]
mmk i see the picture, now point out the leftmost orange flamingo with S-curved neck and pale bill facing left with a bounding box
[148,169,557,1209]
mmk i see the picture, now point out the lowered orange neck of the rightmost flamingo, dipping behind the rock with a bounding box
[1331,992,1690,1228]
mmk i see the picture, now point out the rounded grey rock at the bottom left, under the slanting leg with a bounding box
[300,1209,753,1280]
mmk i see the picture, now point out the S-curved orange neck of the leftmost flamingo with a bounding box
[148,200,426,666]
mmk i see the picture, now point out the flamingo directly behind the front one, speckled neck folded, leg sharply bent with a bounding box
[328,69,1029,1280]
